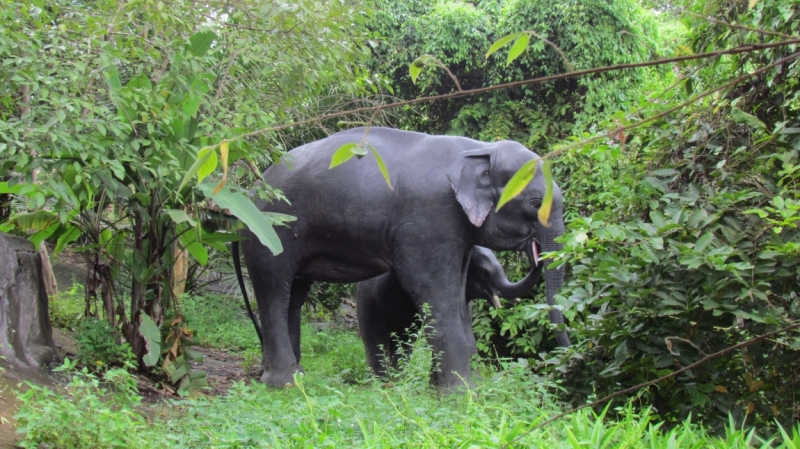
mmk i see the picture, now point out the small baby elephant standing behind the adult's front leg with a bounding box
[356,246,544,376]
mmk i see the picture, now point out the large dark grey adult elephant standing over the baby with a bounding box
[236,127,569,387]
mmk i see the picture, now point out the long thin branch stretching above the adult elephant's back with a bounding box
[197,38,800,149]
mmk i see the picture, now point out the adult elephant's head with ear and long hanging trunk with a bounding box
[447,141,570,346]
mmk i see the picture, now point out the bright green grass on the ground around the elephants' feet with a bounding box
[19,292,800,449]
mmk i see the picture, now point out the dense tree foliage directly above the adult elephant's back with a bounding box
[369,0,659,144]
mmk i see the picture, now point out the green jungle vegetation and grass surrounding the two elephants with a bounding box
[0,0,800,448]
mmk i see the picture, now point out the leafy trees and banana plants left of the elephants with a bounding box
[0,0,374,372]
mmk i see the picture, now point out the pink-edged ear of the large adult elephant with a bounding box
[447,148,494,227]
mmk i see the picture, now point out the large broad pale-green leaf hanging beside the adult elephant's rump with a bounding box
[200,183,283,255]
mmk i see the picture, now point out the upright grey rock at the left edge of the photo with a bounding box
[0,233,58,368]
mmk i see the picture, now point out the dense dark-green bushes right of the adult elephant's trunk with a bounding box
[462,1,800,426]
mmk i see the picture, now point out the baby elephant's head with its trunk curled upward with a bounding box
[466,246,544,308]
